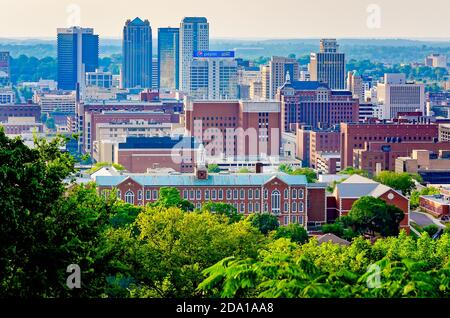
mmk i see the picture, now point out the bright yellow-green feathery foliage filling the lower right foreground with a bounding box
[198,232,450,298]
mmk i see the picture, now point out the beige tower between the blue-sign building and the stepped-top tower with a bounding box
[269,56,300,99]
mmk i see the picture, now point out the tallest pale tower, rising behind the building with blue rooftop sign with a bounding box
[179,17,209,92]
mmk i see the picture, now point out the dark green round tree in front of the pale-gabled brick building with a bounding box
[348,196,405,237]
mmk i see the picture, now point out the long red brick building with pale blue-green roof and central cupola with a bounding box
[96,169,326,227]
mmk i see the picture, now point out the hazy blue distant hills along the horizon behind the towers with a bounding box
[0,38,450,63]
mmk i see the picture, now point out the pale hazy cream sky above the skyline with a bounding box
[0,0,450,39]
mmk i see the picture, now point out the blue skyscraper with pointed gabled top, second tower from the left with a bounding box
[122,18,152,88]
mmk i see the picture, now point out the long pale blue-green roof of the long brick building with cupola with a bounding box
[96,173,307,187]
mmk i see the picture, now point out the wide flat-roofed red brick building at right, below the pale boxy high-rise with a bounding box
[340,123,439,169]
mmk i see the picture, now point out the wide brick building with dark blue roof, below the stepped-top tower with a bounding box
[277,81,359,130]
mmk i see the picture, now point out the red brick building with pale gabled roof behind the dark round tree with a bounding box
[327,175,409,233]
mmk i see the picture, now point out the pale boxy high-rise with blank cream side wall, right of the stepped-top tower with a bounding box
[377,73,425,119]
